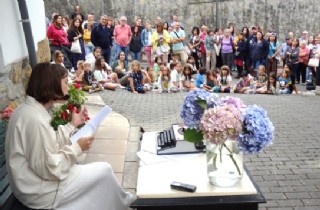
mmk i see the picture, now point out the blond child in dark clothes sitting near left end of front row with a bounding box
[81,62,102,93]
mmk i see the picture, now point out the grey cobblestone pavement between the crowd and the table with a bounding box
[100,89,320,210]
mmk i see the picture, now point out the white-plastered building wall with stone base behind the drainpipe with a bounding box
[0,0,51,112]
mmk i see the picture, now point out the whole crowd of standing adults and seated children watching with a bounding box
[47,5,320,94]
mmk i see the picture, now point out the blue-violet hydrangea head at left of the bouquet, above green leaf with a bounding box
[180,89,220,129]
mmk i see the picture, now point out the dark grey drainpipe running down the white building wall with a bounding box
[17,0,37,68]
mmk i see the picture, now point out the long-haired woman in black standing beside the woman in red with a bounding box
[68,19,85,71]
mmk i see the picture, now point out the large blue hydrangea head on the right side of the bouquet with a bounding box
[237,105,274,154]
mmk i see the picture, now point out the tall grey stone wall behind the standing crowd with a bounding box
[45,0,320,38]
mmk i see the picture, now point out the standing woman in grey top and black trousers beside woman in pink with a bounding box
[286,37,300,93]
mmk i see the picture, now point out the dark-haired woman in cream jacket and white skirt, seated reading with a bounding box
[5,63,132,210]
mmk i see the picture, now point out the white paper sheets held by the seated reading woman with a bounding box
[70,106,112,144]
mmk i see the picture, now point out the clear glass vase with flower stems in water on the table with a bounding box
[206,140,243,187]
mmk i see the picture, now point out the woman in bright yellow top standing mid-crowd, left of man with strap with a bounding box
[152,23,170,64]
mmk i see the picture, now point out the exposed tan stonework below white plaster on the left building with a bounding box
[0,38,50,111]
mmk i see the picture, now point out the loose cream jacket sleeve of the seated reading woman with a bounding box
[24,118,82,180]
